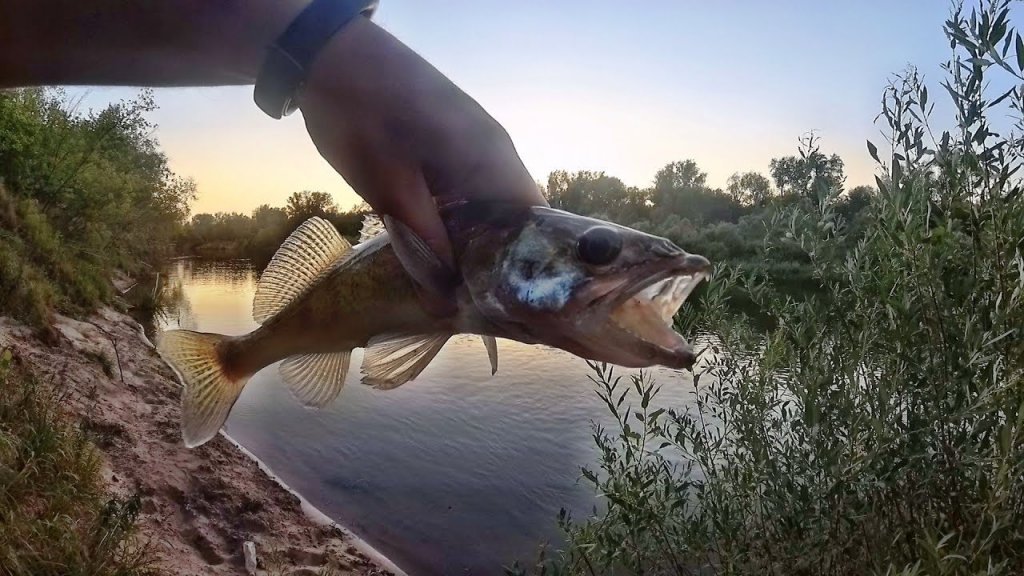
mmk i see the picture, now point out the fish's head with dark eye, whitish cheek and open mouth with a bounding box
[460,206,711,368]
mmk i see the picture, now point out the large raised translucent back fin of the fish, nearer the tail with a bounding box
[253,216,351,324]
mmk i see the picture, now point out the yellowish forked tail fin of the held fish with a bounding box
[157,330,249,448]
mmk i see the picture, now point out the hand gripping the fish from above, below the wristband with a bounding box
[300,18,547,270]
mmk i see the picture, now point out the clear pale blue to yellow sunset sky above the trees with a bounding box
[70,0,949,213]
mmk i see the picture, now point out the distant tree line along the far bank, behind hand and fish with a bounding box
[178,134,877,290]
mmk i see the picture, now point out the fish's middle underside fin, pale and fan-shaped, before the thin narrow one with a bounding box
[362,334,452,389]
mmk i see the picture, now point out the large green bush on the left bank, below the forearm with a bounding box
[0,89,195,328]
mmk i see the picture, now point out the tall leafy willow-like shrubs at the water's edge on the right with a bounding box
[509,0,1024,575]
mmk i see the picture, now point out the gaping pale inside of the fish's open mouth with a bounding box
[608,271,708,360]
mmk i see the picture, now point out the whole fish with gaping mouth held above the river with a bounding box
[157,201,711,447]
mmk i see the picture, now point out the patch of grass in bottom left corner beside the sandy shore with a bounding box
[0,352,158,576]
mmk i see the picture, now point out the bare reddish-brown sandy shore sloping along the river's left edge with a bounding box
[0,308,401,576]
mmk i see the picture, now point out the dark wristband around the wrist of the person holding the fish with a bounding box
[253,0,378,118]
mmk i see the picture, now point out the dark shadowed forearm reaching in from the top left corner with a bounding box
[0,0,307,88]
